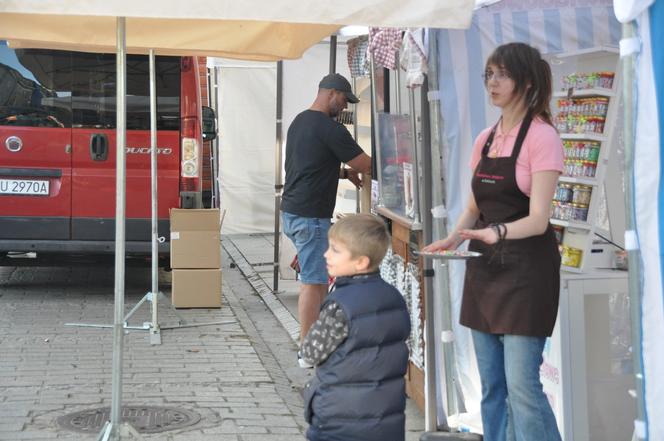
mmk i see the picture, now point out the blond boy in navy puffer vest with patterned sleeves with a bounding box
[301,214,410,441]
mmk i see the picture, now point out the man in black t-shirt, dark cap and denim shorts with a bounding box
[281,73,371,358]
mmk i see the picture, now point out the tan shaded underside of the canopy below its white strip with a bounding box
[0,13,338,61]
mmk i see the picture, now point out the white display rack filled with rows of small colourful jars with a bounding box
[550,47,621,273]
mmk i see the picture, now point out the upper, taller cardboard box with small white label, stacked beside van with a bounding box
[170,208,221,269]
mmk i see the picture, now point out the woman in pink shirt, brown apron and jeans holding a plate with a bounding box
[425,43,563,441]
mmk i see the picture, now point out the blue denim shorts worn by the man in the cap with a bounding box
[281,211,330,285]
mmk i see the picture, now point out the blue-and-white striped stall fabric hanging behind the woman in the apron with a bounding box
[430,0,620,432]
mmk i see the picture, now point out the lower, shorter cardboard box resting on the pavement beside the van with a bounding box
[171,269,221,308]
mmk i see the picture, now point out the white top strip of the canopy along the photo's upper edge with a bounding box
[0,0,474,28]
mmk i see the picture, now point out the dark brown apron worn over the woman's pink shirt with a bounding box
[460,117,560,337]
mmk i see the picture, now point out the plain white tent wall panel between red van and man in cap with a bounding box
[215,59,277,234]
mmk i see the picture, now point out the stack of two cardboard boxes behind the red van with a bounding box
[171,208,221,308]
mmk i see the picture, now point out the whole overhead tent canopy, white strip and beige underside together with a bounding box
[0,0,474,61]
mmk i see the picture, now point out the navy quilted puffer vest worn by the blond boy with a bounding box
[305,274,410,441]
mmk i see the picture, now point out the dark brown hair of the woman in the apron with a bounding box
[484,43,553,125]
